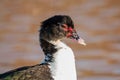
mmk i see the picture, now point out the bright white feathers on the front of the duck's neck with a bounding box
[49,41,77,80]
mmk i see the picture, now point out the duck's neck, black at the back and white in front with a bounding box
[41,40,76,80]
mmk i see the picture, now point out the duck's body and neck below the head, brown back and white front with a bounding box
[0,40,77,80]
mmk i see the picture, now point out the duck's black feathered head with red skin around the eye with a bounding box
[40,15,79,41]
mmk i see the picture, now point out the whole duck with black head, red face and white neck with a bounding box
[0,15,85,80]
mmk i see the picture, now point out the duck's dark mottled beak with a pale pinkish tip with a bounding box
[70,30,86,46]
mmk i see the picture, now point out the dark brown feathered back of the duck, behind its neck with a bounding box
[0,64,54,80]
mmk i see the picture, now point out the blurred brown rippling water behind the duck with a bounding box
[0,0,120,80]
